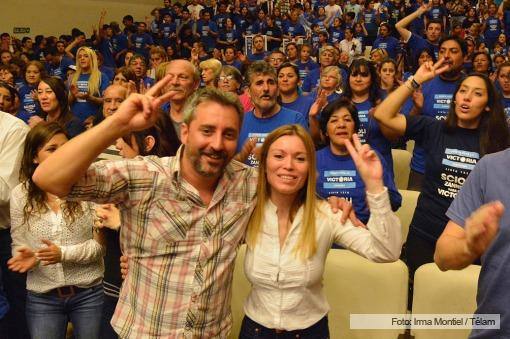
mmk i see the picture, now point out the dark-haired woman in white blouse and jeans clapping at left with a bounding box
[8,123,104,339]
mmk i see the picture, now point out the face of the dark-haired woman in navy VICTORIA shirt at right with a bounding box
[455,76,489,128]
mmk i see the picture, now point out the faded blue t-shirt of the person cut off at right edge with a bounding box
[446,150,510,338]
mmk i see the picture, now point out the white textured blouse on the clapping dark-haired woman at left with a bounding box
[11,184,104,293]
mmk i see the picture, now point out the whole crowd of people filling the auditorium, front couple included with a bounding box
[0,0,510,338]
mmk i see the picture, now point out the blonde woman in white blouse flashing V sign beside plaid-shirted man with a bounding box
[239,125,402,339]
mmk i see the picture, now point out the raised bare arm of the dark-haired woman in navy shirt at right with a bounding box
[374,59,448,138]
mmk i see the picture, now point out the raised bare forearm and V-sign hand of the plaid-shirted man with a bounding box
[33,76,176,197]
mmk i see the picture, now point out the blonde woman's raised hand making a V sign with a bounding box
[344,134,384,194]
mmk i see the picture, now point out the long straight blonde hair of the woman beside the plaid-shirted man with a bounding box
[246,125,317,260]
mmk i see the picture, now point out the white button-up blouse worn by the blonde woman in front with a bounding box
[244,189,402,331]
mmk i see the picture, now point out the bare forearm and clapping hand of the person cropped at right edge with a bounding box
[434,202,504,271]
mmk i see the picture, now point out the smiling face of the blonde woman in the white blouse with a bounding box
[265,135,309,201]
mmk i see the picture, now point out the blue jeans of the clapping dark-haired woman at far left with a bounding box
[26,284,104,339]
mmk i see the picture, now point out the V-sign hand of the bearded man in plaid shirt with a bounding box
[112,75,181,133]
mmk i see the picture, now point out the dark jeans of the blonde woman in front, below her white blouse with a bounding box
[239,316,329,339]
